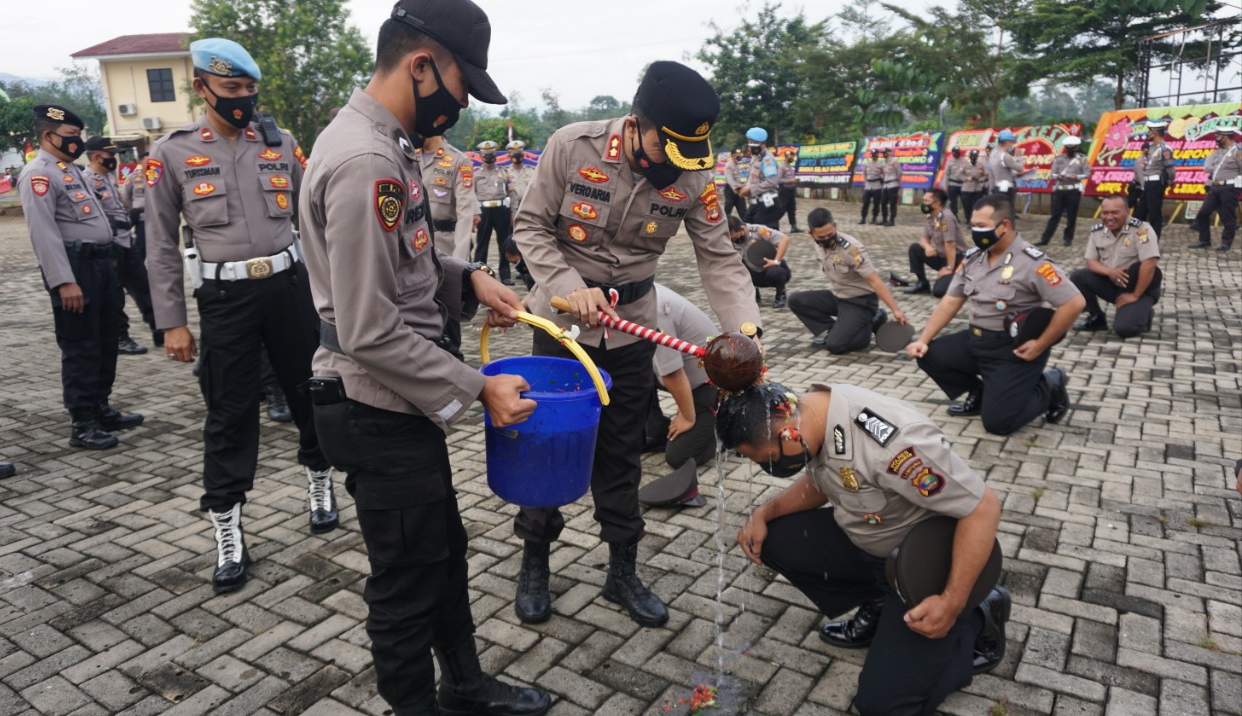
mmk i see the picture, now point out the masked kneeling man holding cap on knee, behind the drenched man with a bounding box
[905,194,1087,435]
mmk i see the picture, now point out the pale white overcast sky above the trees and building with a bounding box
[0,0,924,109]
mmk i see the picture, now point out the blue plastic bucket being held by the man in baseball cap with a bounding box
[479,356,612,507]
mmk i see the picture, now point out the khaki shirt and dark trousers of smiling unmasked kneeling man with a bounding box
[1069,216,1163,338]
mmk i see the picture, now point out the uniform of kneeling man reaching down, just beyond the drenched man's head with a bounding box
[789,231,882,353]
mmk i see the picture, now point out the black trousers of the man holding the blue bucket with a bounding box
[314,400,474,711]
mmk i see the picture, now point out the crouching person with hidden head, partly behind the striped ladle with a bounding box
[646,282,733,469]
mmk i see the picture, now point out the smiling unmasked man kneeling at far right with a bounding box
[1069,195,1163,338]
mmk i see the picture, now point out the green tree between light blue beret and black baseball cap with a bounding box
[190,0,373,152]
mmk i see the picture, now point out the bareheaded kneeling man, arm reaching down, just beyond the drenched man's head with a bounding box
[789,208,907,353]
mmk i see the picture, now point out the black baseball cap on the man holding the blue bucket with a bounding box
[391,0,509,104]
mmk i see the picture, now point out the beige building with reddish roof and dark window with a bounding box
[71,32,202,152]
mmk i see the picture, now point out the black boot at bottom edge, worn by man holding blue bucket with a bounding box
[435,636,551,716]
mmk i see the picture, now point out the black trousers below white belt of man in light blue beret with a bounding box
[195,264,328,510]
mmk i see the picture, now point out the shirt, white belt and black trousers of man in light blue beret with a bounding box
[147,117,329,512]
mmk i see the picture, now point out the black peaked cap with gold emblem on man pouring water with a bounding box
[633,60,720,172]
